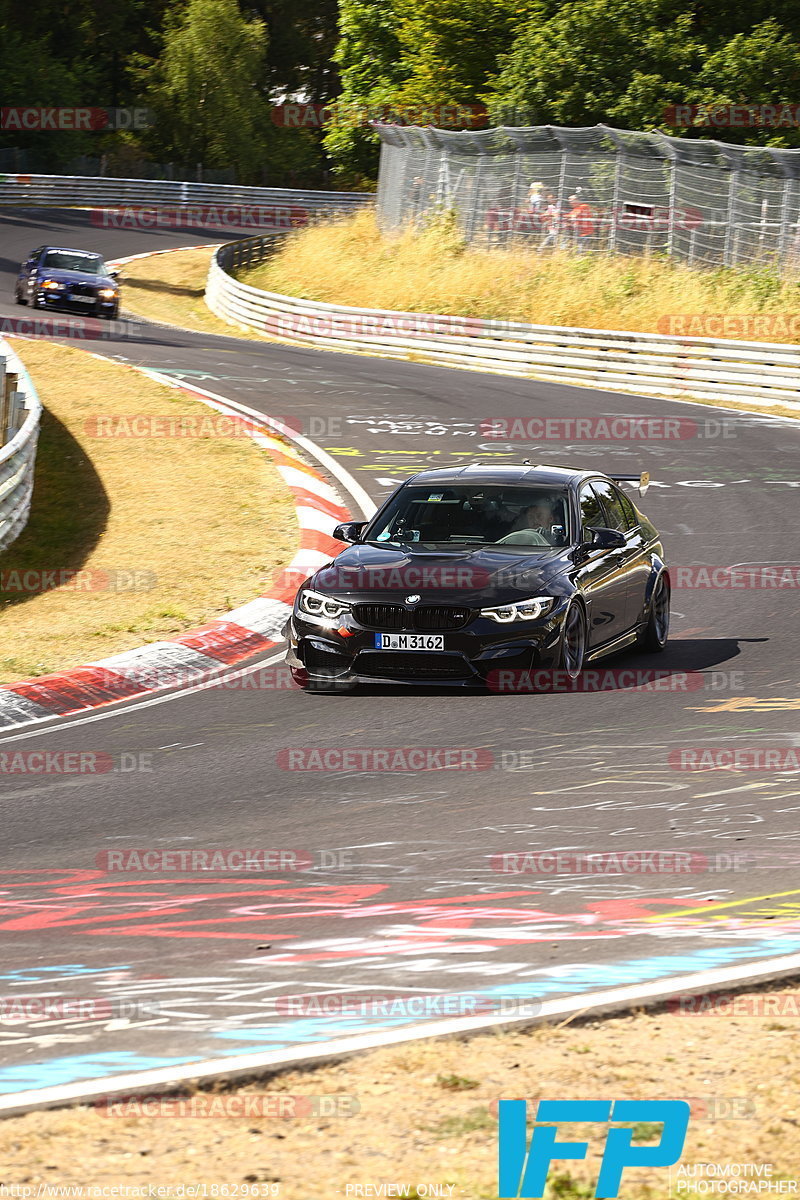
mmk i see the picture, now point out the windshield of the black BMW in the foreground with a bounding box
[366,484,570,552]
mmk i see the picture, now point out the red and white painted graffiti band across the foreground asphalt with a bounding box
[0,869,700,965]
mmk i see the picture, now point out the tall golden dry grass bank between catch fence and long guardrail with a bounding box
[241,211,800,342]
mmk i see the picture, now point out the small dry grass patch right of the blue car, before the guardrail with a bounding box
[120,246,264,342]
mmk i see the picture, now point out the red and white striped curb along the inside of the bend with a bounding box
[0,350,374,730]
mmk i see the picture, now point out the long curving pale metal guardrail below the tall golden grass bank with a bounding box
[205,234,800,403]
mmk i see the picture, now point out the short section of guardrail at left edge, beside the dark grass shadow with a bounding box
[0,340,42,551]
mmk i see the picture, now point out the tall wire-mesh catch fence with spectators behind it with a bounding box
[375,124,800,271]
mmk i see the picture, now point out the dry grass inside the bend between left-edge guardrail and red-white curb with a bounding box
[0,342,297,683]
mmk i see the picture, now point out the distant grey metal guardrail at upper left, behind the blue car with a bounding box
[0,175,374,212]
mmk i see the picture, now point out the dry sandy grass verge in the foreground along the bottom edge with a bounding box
[0,992,800,1200]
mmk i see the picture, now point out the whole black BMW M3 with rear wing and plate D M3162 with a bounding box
[285,464,669,691]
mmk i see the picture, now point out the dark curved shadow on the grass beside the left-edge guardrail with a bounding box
[0,409,110,611]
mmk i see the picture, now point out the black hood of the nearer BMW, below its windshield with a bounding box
[307,544,571,608]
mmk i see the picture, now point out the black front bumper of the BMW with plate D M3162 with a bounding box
[284,605,565,688]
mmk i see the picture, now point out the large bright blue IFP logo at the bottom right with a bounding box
[498,1100,691,1200]
